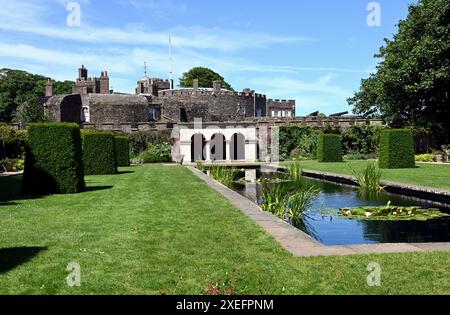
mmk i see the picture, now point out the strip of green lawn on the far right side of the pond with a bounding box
[286,161,450,189]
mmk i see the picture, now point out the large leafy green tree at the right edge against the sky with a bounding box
[348,0,450,141]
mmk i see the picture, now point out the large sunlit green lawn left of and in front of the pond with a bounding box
[0,165,450,294]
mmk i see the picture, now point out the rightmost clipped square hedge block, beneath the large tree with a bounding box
[379,129,416,169]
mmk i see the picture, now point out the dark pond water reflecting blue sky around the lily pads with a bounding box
[234,170,450,245]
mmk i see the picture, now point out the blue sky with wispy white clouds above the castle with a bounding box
[0,0,416,115]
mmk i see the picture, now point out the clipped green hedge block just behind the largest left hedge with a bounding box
[82,130,117,175]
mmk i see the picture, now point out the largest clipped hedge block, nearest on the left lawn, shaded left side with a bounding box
[23,123,85,194]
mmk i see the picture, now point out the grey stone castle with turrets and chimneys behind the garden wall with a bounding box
[44,65,296,130]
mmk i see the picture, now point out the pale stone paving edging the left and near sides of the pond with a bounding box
[187,165,450,257]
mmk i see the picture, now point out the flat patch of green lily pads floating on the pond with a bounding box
[339,201,450,221]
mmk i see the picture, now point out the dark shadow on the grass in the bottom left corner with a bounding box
[0,247,48,274]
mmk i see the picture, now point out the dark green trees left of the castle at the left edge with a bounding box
[0,69,74,122]
